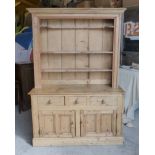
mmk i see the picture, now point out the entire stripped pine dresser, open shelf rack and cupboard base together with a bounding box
[28,8,125,146]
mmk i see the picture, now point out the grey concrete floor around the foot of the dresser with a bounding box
[15,107,139,155]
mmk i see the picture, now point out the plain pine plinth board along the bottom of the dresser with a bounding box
[33,137,124,146]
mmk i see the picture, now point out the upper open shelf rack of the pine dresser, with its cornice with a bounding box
[28,8,125,89]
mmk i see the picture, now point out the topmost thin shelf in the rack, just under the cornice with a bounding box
[40,25,114,30]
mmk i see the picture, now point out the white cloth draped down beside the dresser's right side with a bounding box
[119,67,139,127]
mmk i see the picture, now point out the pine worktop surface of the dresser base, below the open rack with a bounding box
[29,84,123,95]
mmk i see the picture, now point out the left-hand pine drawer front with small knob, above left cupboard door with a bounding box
[38,96,64,106]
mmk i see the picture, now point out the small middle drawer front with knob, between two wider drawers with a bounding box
[65,96,87,105]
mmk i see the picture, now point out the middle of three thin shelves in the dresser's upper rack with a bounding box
[41,51,113,54]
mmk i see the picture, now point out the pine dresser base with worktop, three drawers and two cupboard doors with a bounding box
[30,85,124,146]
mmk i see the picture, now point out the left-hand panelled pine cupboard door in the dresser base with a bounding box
[39,111,75,137]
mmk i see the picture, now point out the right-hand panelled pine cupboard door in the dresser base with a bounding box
[81,110,116,136]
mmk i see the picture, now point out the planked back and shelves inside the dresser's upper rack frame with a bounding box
[30,14,121,85]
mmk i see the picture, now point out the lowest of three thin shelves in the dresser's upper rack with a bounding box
[42,68,112,73]
